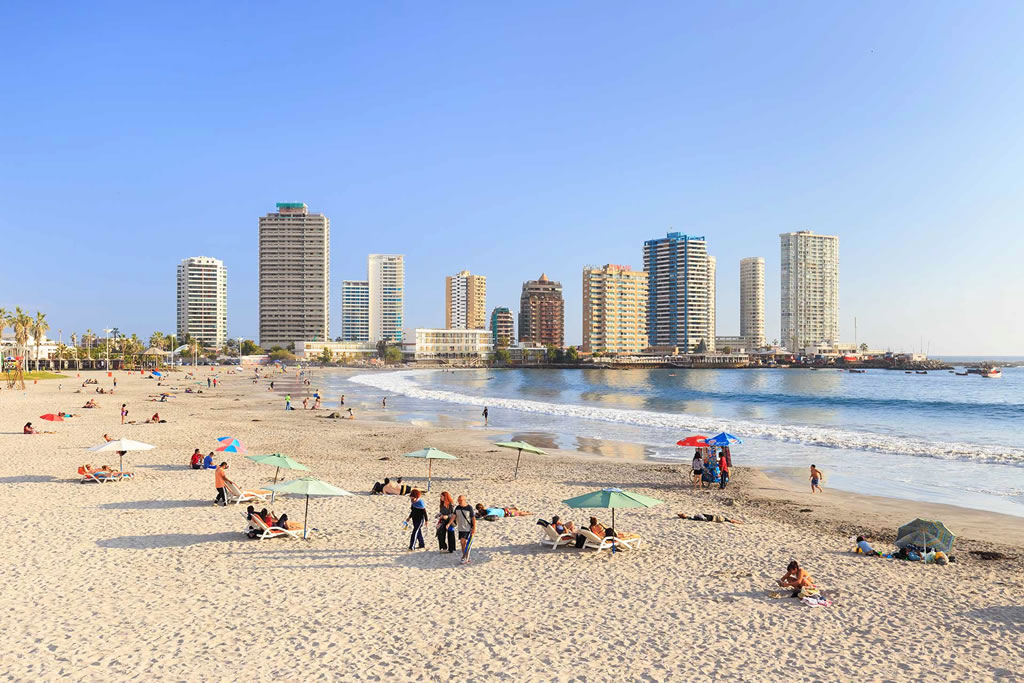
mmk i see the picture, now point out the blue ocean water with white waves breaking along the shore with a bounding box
[315,368,1024,516]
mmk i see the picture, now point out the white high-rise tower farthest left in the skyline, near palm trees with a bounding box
[178,256,227,349]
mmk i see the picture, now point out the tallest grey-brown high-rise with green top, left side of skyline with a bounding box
[259,202,331,347]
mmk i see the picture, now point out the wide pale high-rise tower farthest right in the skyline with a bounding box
[778,230,839,352]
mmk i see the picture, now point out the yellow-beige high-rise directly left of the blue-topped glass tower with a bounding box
[583,264,647,353]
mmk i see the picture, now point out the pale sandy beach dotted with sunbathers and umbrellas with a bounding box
[0,369,1024,681]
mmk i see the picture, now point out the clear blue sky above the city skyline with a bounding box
[0,2,1024,354]
